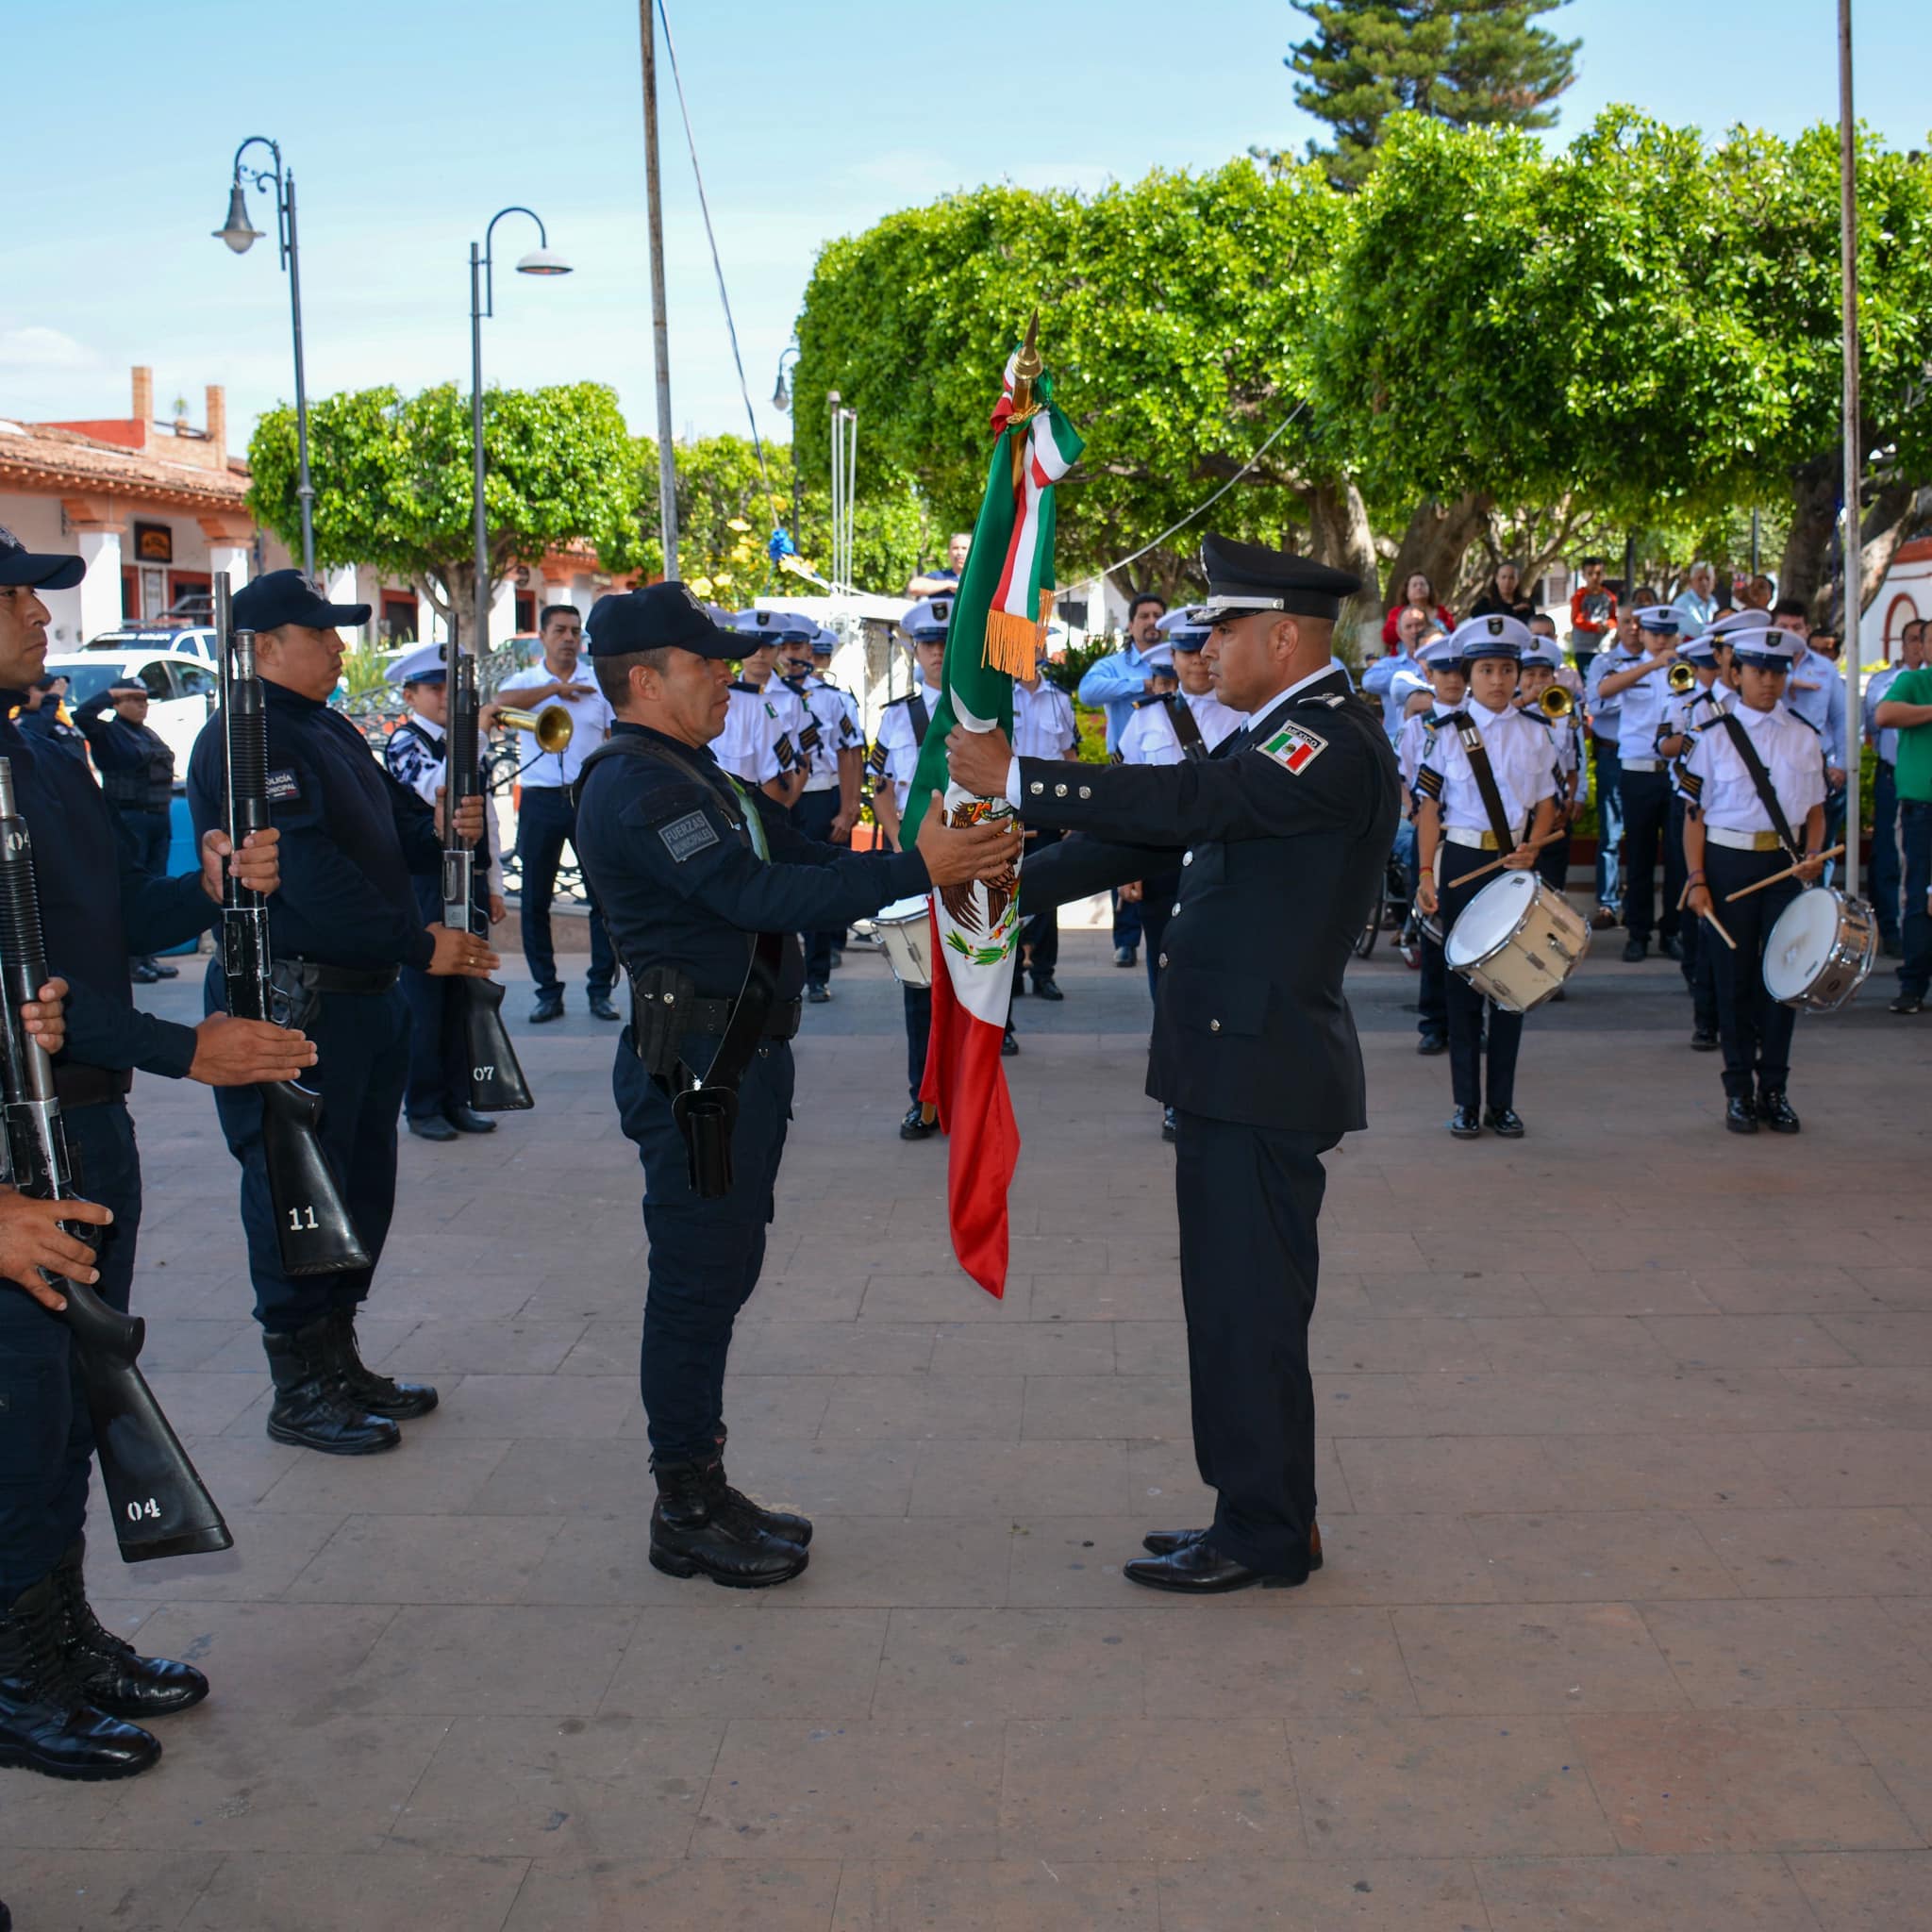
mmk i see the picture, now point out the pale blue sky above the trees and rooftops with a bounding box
[0,0,1932,461]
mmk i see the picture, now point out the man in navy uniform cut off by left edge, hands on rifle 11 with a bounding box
[0,529,315,1779]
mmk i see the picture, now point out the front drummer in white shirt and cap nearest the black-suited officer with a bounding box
[1416,616,1557,1140]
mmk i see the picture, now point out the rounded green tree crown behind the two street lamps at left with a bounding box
[249,383,651,633]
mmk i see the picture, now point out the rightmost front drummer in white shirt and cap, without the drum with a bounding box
[1683,628,1825,1134]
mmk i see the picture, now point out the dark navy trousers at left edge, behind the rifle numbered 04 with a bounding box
[0,1101,142,1609]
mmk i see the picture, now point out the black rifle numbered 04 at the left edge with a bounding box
[0,758,234,1563]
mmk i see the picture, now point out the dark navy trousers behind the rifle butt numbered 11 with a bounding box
[207,957,409,1335]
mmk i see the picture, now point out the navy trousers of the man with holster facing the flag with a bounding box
[610,1025,792,1464]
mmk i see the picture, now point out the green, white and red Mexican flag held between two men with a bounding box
[902,328,1082,1294]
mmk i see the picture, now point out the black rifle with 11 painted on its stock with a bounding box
[214,572,373,1275]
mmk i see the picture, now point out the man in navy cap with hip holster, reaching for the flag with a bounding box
[577,581,1012,1591]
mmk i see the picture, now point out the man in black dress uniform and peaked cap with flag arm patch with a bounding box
[947,537,1401,1594]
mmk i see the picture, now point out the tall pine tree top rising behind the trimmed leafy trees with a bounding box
[1277,0,1580,188]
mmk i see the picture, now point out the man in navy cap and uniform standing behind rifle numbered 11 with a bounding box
[188,570,496,1455]
